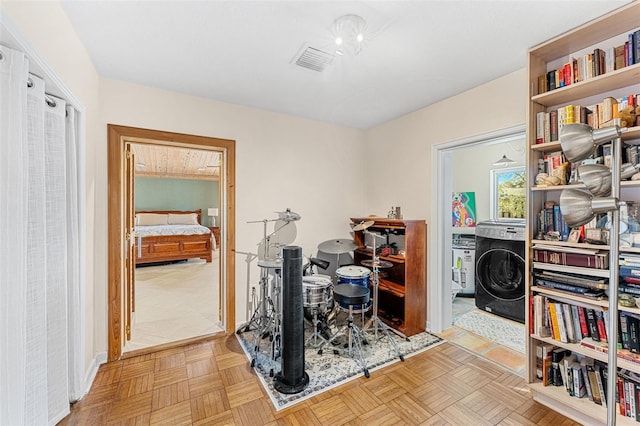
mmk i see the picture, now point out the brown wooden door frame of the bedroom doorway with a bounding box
[108,125,235,361]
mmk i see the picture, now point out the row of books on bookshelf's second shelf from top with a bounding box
[536,93,640,144]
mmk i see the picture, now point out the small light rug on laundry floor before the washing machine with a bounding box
[454,309,526,353]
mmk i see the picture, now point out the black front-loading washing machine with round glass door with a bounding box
[475,221,526,323]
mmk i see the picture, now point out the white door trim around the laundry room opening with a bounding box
[427,124,525,333]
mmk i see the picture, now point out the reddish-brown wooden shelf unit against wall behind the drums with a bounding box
[351,217,427,336]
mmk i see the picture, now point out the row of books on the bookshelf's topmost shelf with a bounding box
[538,30,640,94]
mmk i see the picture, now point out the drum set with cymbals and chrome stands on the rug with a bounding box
[237,209,404,378]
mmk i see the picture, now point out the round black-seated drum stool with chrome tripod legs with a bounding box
[318,284,369,378]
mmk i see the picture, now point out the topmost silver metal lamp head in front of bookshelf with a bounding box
[559,123,620,163]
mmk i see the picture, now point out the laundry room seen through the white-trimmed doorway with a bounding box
[445,132,526,374]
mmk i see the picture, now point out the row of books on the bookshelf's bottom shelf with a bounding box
[536,343,640,422]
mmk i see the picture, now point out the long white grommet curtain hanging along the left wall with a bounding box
[0,46,82,425]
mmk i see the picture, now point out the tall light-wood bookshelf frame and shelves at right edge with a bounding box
[525,1,640,425]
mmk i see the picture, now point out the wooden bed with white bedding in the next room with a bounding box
[135,210,213,265]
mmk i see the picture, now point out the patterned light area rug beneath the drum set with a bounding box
[236,318,444,410]
